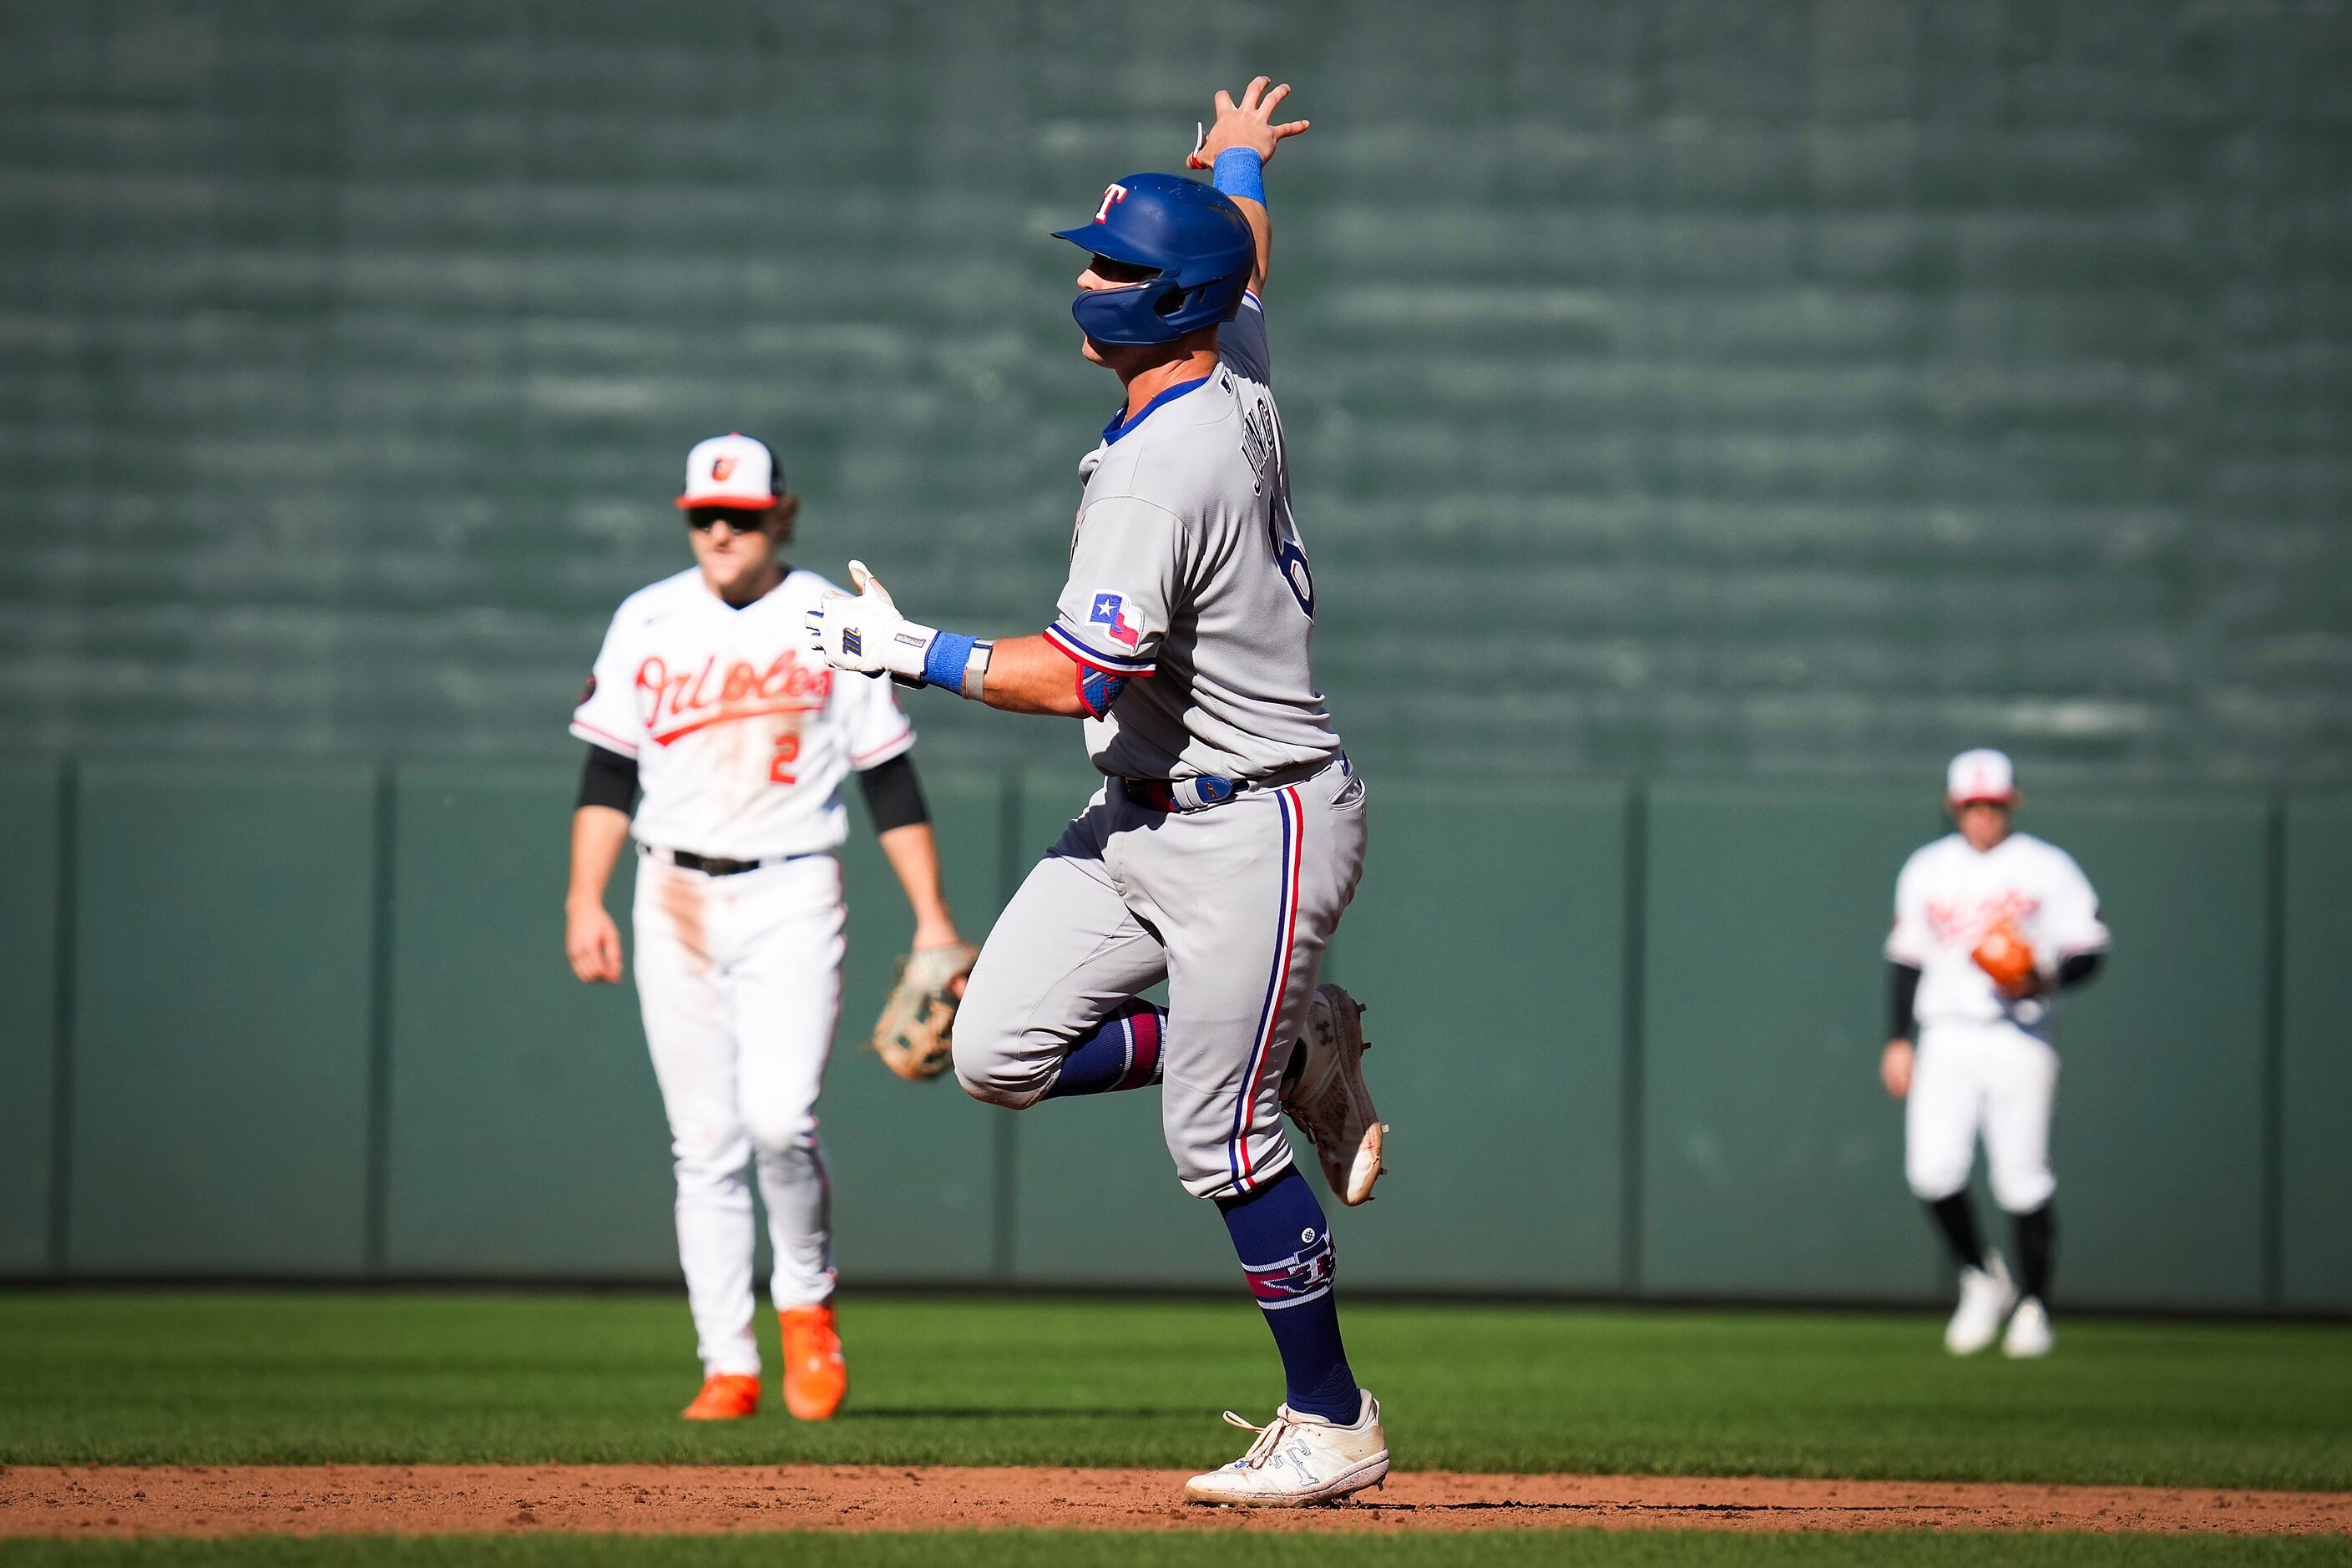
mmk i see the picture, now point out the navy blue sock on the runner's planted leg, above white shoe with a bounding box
[1216,1166,1364,1427]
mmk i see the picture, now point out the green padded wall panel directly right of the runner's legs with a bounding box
[1336,778,1626,1293]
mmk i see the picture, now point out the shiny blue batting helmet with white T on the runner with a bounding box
[1054,174,1258,343]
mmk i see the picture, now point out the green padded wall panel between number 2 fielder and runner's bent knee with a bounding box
[818,766,1004,1286]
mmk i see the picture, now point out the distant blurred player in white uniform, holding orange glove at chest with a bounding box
[1879,750,2107,1357]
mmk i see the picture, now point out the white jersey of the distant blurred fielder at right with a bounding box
[1886,832,2107,1039]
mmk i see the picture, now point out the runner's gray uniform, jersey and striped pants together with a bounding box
[955,294,1367,1196]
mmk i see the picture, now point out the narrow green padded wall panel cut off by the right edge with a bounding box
[2279,795,2352,1312]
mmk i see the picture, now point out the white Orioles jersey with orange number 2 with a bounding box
[572,567,915,861]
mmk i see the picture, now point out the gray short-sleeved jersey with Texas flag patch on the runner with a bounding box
[1044,294,1338,778]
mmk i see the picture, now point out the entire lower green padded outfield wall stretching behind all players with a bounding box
[0,759,2352,1314]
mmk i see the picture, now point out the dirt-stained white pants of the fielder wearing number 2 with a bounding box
[635,856,847,1375]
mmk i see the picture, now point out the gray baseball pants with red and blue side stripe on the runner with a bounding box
[955,757,1367,1199]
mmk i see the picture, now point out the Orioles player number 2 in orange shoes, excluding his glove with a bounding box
[564,435,959,1420]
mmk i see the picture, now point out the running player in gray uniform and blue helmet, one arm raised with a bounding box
[809,78,1388,1505]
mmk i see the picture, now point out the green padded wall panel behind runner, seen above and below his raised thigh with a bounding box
[1002,766,1242,1288]
